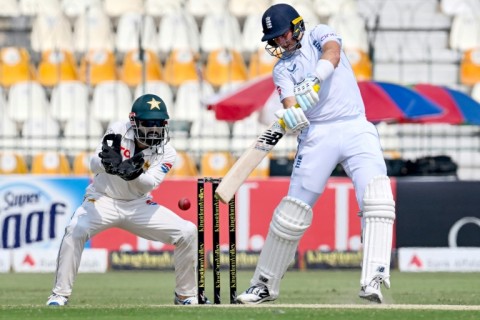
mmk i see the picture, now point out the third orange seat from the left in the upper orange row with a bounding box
[79,49,118,86]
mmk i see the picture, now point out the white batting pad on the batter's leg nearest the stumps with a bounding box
[252,197,313,297]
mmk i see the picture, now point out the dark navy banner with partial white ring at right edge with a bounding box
[396,179,480,248]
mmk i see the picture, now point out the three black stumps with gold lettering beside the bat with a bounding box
[197,177,237,304]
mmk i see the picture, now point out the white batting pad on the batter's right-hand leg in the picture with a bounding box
[360,176,395,288]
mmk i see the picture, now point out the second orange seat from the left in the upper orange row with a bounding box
[37,50,78,87]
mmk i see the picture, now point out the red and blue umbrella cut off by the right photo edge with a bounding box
[414,84,480,125]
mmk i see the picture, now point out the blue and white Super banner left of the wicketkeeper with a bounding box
[0,176,89,250]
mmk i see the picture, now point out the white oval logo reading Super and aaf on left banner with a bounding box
[0,183,71,249]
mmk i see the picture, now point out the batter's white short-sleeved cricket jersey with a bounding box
[273,24,365,122]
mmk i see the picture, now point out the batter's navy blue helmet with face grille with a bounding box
[262,3,305,58]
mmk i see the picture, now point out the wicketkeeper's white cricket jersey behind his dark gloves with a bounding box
[86,121,177,201]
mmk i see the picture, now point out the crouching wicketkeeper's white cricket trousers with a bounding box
[53,195,197,297]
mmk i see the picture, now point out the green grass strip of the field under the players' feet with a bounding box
[0,270,480,320]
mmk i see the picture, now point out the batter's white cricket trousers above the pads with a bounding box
[288,116,387,209]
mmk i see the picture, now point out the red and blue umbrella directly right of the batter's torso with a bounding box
[358,81,443,122]
